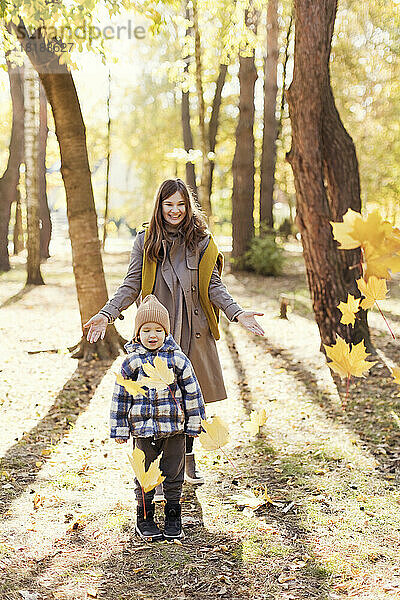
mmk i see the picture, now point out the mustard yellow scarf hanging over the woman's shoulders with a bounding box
[142,227,224,340]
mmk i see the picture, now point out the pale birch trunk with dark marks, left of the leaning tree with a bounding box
[24,61,44,285]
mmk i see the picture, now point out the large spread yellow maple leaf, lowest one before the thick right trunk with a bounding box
[324,337,376,377]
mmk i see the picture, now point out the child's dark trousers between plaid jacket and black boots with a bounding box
[133,433,186,506]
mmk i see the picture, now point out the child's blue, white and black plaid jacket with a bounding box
[110,335,206,439]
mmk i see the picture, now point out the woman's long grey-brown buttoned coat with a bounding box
[100,231,243,402]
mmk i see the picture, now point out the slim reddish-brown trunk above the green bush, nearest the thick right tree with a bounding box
[260,0,279,235]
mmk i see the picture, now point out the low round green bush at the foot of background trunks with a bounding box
[239,233,285,276]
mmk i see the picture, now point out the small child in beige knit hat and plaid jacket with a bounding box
[111,294,205,540]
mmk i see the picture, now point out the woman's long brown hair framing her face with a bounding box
[145,178,207,261]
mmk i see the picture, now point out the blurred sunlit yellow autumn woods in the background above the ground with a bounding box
[0,0,400,354]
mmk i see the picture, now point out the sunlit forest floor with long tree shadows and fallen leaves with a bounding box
[0,240,400,600]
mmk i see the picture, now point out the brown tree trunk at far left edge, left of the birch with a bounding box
[0,59,24,271]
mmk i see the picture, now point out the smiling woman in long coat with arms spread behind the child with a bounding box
[84,179,264,484]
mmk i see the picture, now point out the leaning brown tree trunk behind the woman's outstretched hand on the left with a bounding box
[14,23,123,360]
